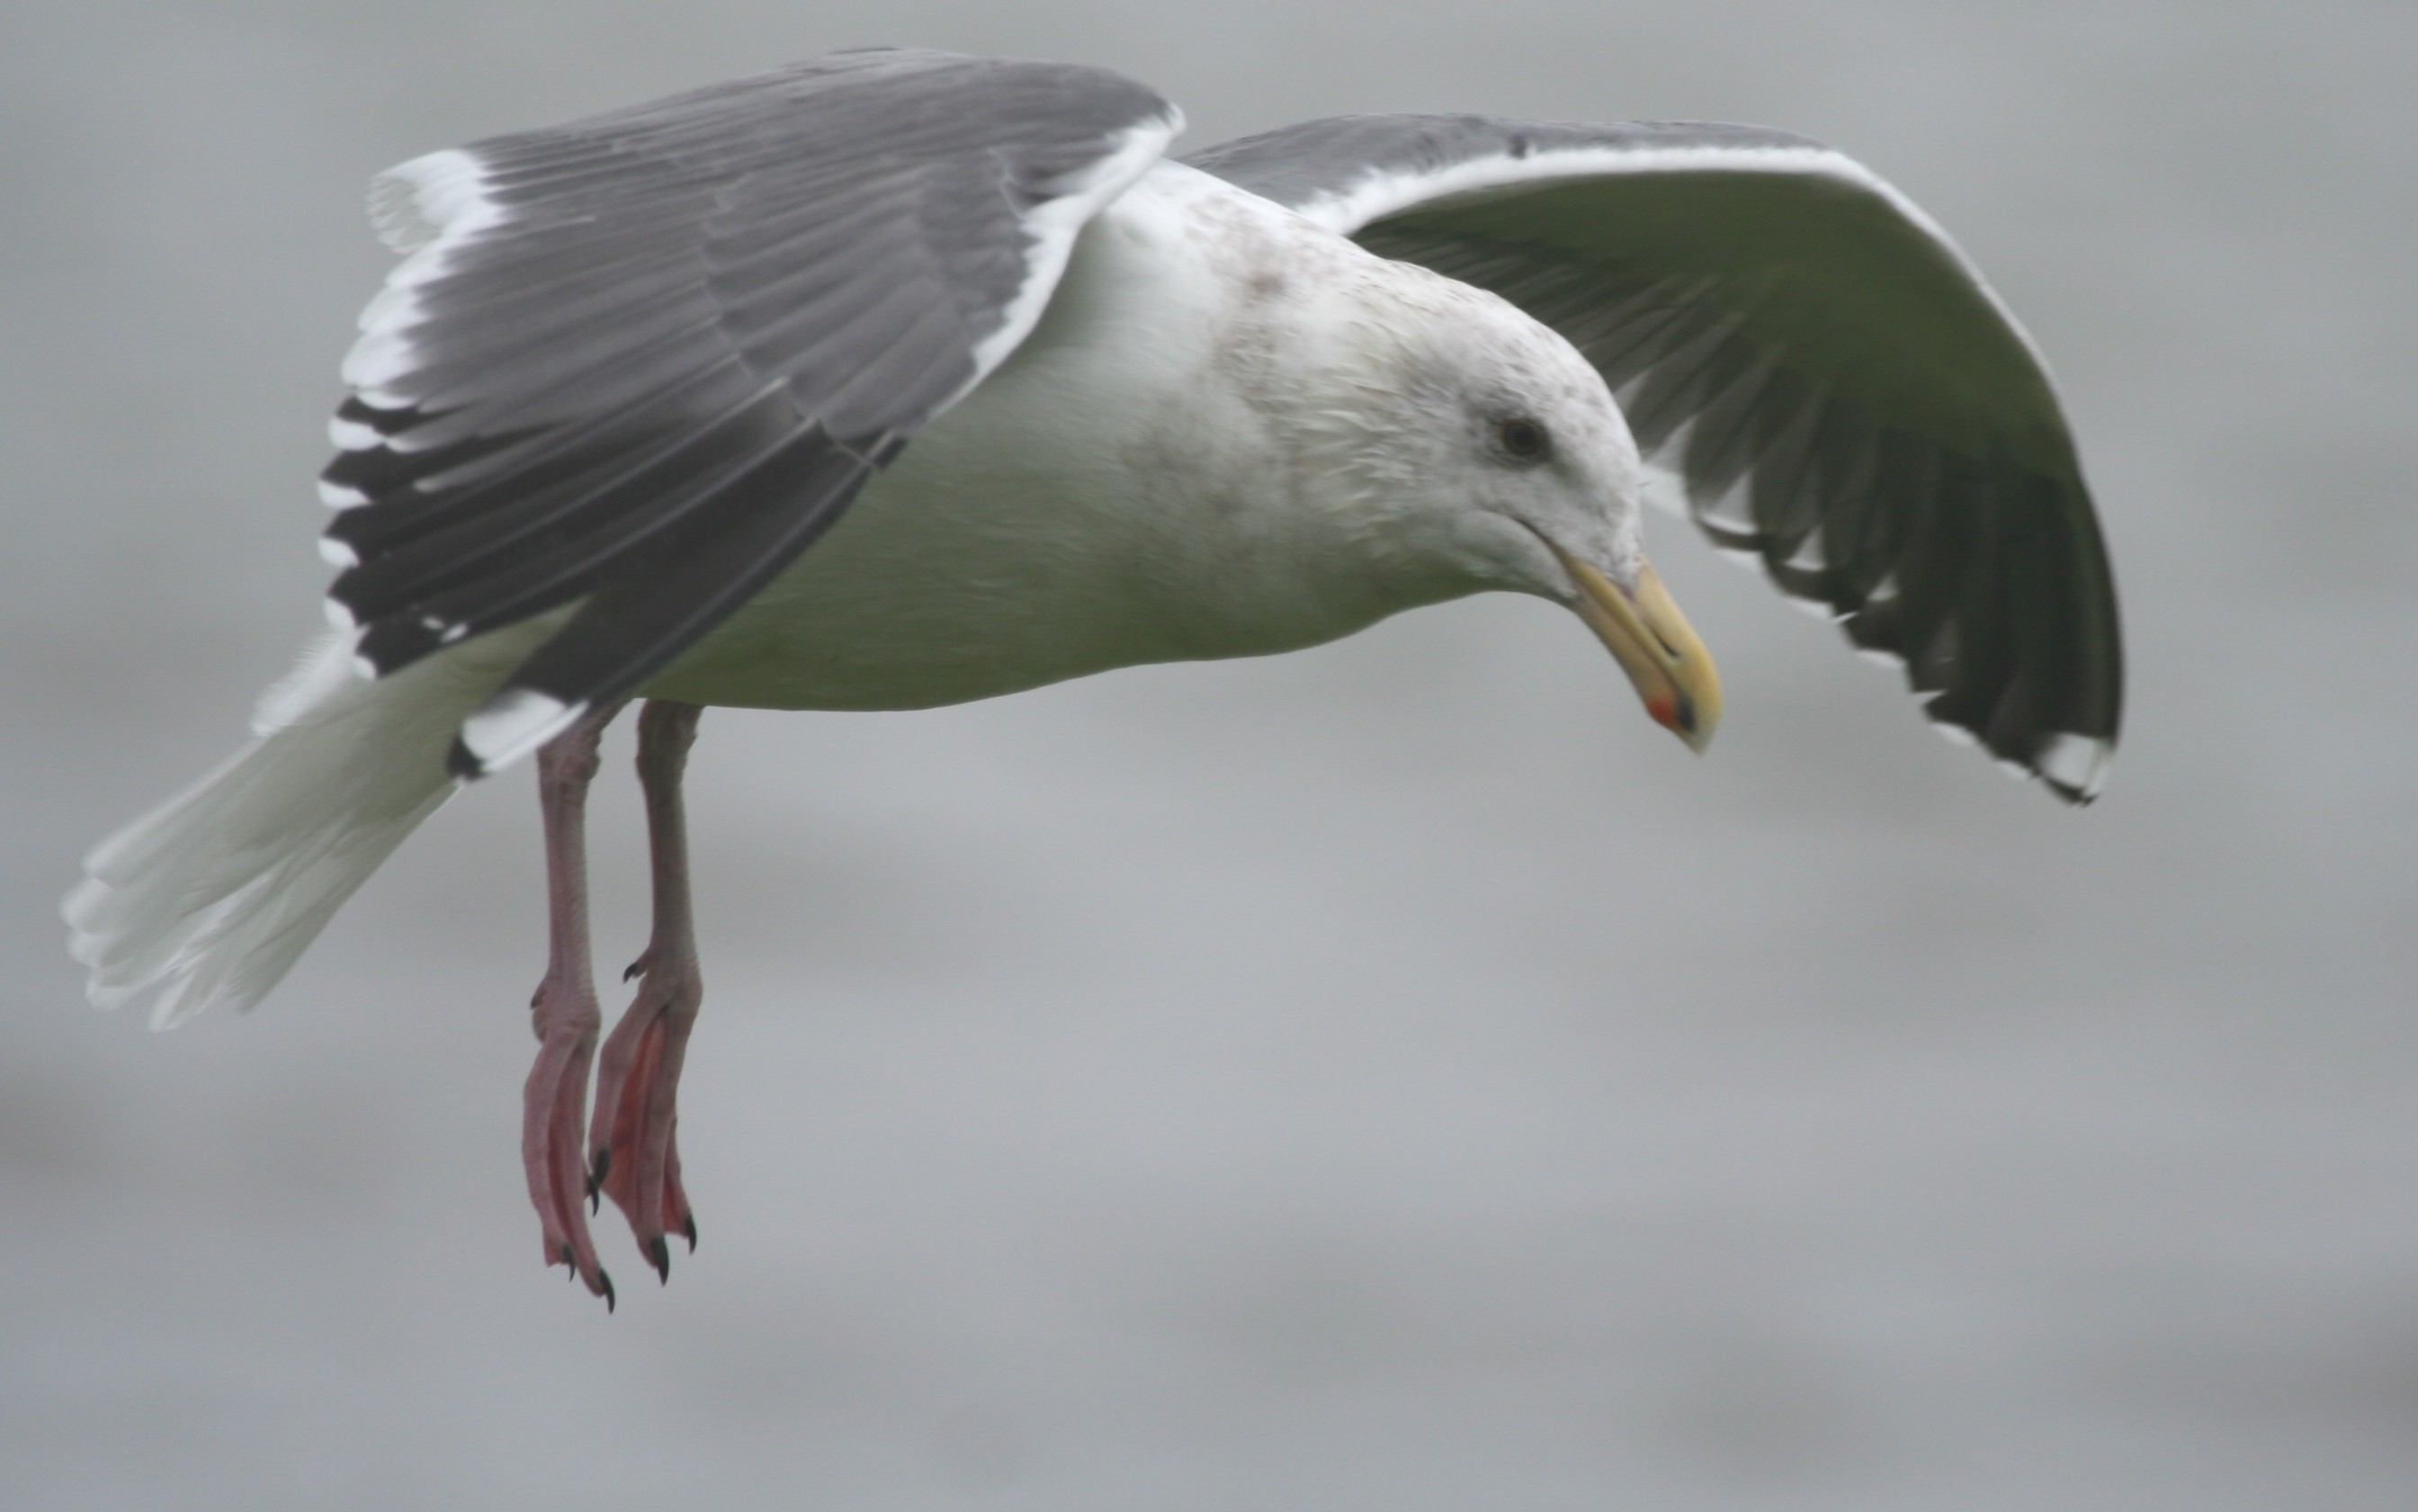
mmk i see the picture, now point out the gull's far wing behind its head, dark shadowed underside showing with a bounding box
[1185,116,2123,801]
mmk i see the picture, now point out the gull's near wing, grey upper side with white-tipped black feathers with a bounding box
[322,50,1180,776]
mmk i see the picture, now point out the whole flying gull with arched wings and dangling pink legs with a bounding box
[66,49,2120,1302]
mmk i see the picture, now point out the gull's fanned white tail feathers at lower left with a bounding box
[60,616,542,1028]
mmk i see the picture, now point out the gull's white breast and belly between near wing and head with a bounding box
[646,165,1465,709]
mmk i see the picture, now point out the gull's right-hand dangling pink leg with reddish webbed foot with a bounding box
[587,699,706,1280]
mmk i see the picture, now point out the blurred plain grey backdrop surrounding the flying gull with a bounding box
[0,0,2418,1512]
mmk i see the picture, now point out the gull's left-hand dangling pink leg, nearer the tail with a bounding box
[520,704,622,1311]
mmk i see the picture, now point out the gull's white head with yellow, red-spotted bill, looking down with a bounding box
[1315,264,1722,750]
